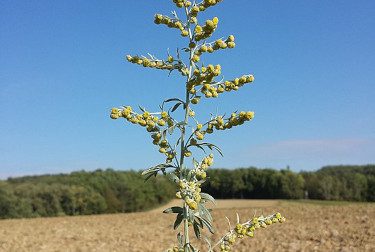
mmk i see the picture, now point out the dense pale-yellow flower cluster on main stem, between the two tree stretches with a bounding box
[176,179,202,210]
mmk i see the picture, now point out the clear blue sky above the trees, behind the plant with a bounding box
[0,0,375,178]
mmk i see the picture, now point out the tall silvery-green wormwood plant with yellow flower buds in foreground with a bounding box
[111,0,285,252]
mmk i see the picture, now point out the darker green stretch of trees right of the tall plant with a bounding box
[204,165,375,201]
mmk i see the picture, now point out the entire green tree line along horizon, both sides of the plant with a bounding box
[0,165,375,218]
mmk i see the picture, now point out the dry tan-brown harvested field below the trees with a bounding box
[0,200,375,252]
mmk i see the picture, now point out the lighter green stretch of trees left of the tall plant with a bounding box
[0,169,175,218]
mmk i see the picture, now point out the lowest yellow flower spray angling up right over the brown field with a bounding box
[220,213,285,252]
